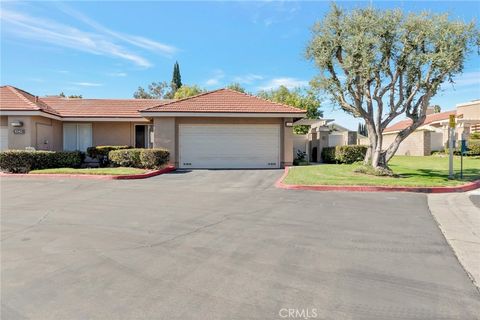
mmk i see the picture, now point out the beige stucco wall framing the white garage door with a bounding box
[153,117,293,166]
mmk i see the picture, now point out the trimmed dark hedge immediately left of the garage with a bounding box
[108,149,170,169]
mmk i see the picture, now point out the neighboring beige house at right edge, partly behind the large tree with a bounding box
[383,100,480,156]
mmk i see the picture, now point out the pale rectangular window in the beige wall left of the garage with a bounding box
[63,123,92,151]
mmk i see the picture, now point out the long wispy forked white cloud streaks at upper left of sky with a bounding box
[0,8,177,68]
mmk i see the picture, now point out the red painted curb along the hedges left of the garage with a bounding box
[0,166,176,180]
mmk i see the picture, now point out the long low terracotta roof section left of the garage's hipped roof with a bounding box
[41,97,171,118]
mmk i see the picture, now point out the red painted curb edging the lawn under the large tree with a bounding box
[275,167,480,193]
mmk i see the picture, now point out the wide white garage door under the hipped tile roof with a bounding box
[178,124,280,169]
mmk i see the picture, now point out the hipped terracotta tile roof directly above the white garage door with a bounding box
[141,89,305,116]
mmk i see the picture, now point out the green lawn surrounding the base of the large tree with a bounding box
[284,156,480,187]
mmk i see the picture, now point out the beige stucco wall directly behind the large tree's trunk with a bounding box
[383,130,431,156]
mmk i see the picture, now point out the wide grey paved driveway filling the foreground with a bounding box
[1,170,480,320]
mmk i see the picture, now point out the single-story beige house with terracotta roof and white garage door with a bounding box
[0,86,305,168]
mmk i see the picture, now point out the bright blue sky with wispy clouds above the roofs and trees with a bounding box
[0,1,480,129]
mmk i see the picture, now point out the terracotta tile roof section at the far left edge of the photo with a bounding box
[0,86,59,116]
